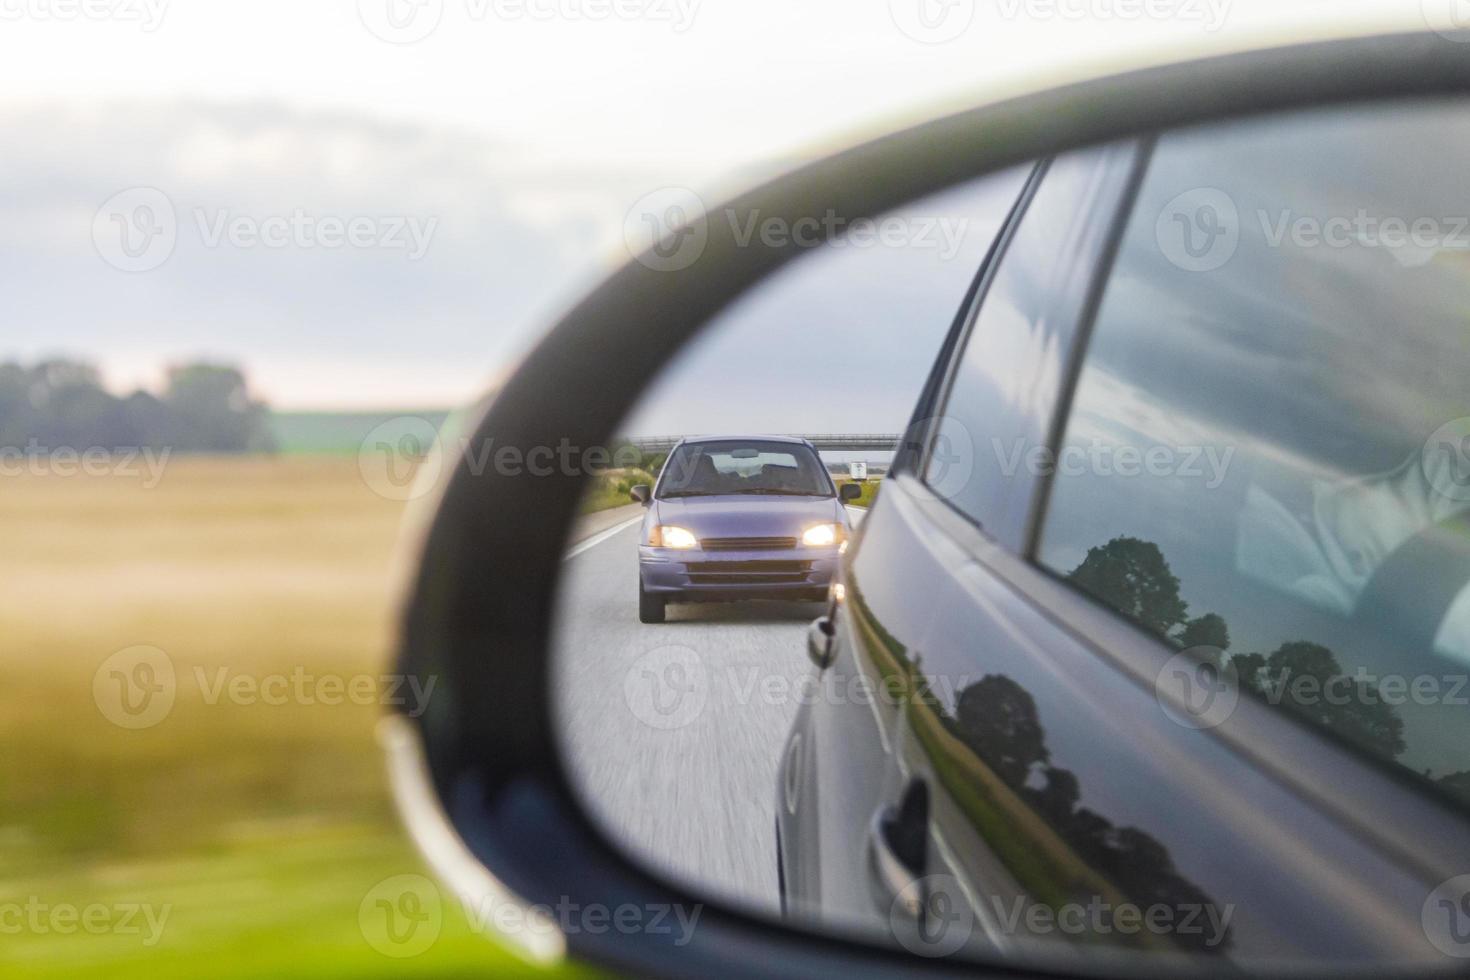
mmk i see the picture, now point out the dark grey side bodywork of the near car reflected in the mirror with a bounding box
[776,123,1470,970]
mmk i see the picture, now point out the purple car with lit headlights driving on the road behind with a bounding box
[632,436,861,623]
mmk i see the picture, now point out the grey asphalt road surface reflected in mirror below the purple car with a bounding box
[553,525,823,912]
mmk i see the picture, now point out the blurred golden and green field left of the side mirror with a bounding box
[0,457,585,977]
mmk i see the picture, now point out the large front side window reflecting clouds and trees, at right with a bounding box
[1039,103,1470,798]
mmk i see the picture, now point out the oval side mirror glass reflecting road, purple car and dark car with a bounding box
[554,95,1470,970]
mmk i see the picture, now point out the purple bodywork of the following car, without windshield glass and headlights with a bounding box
[638,436,851,621]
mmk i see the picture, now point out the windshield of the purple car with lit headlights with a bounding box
[659,441,832,497]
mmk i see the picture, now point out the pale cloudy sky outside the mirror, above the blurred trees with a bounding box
[0,0,1417,408]
